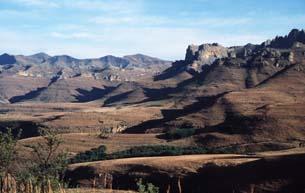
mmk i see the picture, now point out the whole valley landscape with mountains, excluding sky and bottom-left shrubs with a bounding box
[0,29,305,193]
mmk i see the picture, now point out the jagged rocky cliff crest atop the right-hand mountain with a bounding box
[156,29,305,80]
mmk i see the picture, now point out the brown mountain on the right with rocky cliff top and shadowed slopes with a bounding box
[127,30,305,152]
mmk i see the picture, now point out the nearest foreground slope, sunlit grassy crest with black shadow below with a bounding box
[67,150,305,193]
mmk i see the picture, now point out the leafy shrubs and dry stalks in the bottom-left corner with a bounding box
[0,129,68,193]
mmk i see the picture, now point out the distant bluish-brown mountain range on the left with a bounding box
[0,53,171,103]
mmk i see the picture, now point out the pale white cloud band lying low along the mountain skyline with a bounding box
[0,25,267,60]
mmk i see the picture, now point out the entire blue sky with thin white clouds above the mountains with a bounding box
[0,0,305,60]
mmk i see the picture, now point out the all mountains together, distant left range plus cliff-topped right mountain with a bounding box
[0,29,305,157]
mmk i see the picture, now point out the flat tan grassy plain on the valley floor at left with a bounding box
[0,103,166,133]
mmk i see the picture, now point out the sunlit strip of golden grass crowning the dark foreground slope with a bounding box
[70,154,258,174]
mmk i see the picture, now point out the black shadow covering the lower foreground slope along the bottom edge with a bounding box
[65,154,305,193]
